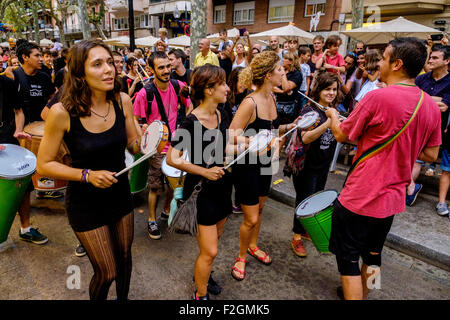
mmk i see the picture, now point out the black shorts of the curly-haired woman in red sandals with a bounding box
[233,165,272,206]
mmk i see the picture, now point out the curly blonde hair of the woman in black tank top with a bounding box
[239,51,280,88]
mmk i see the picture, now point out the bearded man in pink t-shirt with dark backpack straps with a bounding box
[133,51,191,240]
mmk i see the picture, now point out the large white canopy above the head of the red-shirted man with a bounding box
[341,17,442,44]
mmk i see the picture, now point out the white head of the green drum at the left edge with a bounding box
[0,144,36,180]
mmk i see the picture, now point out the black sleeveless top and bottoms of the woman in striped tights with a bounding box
[64,101,133,232]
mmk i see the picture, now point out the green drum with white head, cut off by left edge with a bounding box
[0,144,36,243]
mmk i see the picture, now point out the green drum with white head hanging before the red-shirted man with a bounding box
[295,190,338,253]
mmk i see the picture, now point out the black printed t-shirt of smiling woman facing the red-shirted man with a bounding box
[300,104,337,174]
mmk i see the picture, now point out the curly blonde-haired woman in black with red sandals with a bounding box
[230,51,302,281]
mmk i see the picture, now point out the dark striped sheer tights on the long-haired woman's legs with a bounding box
[75,213,134,300]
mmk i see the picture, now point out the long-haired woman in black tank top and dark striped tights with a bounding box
[37,40,140,300]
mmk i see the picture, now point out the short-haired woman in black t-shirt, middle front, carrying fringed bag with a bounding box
[167,65,237,300]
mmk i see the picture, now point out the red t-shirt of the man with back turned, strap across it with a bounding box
[339,85,441,218]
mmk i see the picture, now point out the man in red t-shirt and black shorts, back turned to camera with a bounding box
[327,38,441,300]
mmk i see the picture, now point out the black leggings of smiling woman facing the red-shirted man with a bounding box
[292,169,328,234]
